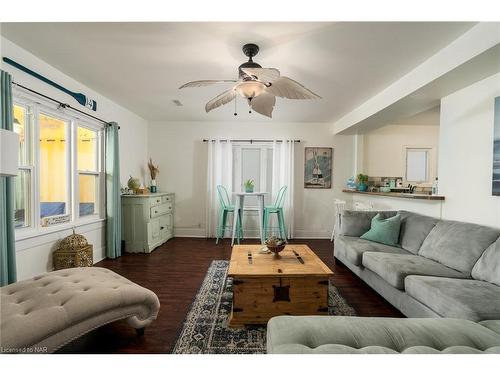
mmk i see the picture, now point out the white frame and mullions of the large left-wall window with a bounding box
[13,87,106,241]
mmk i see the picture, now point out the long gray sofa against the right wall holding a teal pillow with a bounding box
[334,211,500,322]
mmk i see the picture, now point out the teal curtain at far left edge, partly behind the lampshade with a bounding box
[0,70,16,286]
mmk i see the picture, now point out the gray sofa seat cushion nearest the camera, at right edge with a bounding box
[405,275,500,321]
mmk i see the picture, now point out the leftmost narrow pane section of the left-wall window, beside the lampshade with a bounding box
[14,103,33,228]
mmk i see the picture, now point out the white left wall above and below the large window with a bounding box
[0,37,147,280]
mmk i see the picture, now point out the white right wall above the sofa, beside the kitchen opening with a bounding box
[439,73,500,228]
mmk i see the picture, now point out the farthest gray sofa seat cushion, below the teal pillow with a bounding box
[334,236,410,266]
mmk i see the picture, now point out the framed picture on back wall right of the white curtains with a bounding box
[304,147,333,189]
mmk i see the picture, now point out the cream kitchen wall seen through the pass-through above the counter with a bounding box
[363,124,439,181]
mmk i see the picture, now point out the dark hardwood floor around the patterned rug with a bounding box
[60,238,403,353]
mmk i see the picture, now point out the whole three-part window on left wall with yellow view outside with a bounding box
[14,93,104,236]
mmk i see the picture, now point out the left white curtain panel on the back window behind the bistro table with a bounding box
[205,139,233,238]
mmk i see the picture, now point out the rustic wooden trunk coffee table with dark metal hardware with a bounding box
[228,245,333,326]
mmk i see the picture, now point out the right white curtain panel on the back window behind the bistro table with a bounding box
[272,139,295,239]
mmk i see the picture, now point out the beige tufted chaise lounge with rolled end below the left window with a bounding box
[0,267,160,353]
